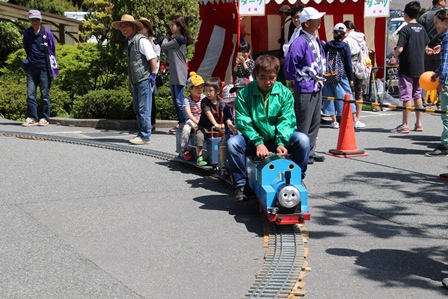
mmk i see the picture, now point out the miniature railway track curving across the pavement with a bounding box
[0,131,310,299]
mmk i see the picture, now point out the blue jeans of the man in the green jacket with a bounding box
[227,131,310,187]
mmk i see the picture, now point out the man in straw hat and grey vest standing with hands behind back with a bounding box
[112,14,157,145]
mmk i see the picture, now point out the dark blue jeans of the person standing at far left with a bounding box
[26,65,51,120]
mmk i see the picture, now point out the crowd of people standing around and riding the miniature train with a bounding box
[18,0,448,287]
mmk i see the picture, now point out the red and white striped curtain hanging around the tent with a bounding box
[189,0,386,83]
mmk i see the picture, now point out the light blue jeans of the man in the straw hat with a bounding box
[132,80,153,140]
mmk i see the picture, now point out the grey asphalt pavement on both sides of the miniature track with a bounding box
[0,106,448,298]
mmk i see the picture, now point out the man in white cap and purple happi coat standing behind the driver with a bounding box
[284,7,325,164]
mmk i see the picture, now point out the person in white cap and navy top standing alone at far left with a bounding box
[22,9,58,127]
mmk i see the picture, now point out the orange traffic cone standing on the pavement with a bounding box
[327,93,368,158]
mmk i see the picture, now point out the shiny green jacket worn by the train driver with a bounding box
[235,81,297,147]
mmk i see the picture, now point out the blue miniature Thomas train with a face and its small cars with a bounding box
[176,130,311,225]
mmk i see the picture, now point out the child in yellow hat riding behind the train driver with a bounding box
[181,72,205,161]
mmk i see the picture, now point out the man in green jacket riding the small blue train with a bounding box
[227,55,310,201]
